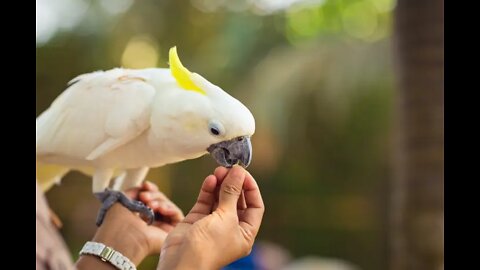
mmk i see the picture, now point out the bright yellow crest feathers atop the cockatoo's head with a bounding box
[168,46,207,95]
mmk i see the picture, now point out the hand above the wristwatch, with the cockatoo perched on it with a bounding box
[79,182,184,268]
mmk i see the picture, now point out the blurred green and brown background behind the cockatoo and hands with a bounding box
[36,0,443,270]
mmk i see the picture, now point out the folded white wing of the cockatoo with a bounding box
[37,69,155,160]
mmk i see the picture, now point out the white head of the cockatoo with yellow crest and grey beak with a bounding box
[150,47,255,167]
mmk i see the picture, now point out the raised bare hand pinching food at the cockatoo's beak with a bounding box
[157,166,265,270]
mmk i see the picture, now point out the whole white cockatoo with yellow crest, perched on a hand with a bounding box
[36,47,255,226]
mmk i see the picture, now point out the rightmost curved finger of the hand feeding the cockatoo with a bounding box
[239,173,265,236]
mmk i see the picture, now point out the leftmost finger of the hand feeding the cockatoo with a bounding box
[184,175,217,223]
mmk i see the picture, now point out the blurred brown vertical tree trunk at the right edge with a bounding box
[390,0,444,270]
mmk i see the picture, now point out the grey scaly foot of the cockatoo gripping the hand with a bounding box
[94,188,154,226]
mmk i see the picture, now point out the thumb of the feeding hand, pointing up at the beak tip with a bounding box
[218,165,245,211]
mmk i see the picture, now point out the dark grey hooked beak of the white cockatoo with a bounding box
[207,136,252,168]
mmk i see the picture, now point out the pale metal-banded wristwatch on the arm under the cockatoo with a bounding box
[80,241,137,270]
